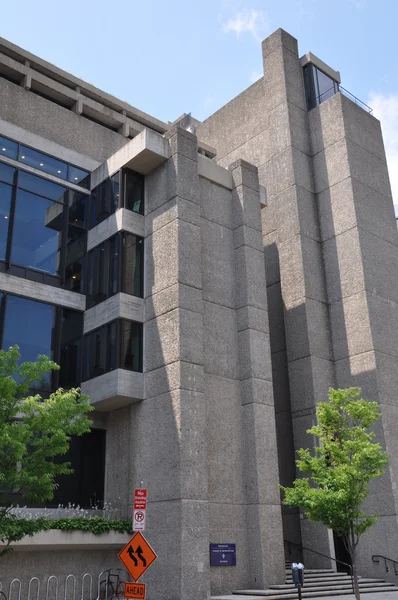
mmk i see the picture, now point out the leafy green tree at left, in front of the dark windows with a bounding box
[0,346,92,556]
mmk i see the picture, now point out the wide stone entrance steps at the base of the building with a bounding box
[211,568,398,600]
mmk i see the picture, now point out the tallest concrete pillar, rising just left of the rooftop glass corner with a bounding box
[259,29,334,567]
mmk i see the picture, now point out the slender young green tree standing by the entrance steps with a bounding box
[282,387,388,600]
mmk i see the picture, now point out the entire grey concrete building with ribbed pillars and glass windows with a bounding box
[0,30,398,600]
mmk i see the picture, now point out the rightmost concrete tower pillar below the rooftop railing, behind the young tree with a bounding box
[309,94,398,576]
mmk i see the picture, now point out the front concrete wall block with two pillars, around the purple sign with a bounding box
[102,129,284,598]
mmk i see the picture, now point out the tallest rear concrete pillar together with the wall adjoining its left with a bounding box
[198,30,334,567]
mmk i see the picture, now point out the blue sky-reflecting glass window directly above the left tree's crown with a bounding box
[3,295,55,389]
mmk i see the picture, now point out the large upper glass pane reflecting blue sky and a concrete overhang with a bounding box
[11,190,63,275]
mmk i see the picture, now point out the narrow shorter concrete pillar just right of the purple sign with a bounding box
[229,160,284,589]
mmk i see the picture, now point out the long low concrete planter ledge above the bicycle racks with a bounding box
[0,529,131,552]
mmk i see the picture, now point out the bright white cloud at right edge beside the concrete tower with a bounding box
[368,92,398,214]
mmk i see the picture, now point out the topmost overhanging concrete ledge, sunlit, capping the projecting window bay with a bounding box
[91,129,170,189]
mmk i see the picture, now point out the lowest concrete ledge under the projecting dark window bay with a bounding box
[82,369,144,412]
